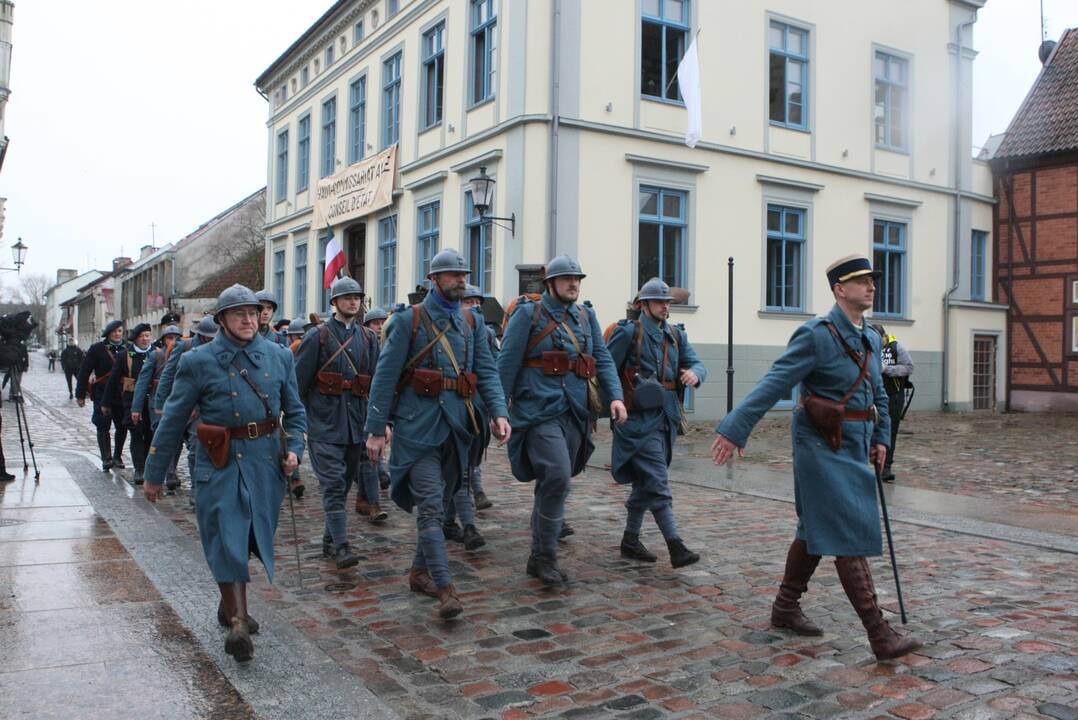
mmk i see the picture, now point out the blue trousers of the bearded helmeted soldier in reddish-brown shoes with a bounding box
[407,438,460,587]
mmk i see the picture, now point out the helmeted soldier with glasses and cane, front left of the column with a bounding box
[142,285,306,662]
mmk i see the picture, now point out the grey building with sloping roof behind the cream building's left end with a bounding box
[116,189,265,330]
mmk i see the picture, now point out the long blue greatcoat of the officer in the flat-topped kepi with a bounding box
[717,305,890,557]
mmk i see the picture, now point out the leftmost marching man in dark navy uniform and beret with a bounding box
[74,320,127,472]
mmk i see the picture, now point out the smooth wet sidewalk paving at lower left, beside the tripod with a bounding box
[0,459,254,720]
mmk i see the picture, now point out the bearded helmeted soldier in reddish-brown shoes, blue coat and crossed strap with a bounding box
[365,249,511,619]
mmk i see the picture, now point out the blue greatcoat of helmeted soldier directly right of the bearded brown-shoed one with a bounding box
[498,292,623,482]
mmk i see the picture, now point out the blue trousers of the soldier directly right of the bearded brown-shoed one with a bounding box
[524,413,584,557]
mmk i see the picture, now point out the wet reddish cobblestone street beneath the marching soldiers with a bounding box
[0,357,1078,720]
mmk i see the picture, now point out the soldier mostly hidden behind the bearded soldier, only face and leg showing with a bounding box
[442,285,498,550]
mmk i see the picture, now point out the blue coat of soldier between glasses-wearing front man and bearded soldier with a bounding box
[295,317,378,445]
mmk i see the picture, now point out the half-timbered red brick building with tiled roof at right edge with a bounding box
[987,28,1078,412]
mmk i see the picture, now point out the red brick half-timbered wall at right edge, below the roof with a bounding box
[995,164,1078,391]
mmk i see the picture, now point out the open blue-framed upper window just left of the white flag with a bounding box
[640,0,689,101]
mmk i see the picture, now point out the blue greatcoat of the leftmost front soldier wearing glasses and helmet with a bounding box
[146,332,307,582]
